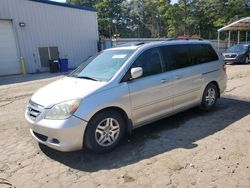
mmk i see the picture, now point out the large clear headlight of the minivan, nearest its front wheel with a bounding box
[45,99,81,120]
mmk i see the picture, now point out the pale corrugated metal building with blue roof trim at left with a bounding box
[0,0,98,76]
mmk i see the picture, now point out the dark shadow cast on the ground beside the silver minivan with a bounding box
[40,98,250,172]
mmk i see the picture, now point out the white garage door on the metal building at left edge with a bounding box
[0,20,21,76]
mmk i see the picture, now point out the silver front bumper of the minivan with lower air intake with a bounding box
[25,113,87,152]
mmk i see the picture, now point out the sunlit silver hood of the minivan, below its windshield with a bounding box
[31,77,106,108]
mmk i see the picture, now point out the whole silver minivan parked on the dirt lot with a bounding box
[25,40,227,152]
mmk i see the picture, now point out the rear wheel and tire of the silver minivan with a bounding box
[200,83,219,111]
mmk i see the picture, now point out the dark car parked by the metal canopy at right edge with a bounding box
[223,44,250,64]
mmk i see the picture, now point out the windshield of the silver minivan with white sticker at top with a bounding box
[69,50,134,81]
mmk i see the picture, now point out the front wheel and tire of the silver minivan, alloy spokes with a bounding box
[83,110,125,153]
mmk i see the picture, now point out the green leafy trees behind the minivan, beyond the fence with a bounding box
[67,0,250,39]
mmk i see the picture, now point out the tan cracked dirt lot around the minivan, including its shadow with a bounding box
[0,65,250,188]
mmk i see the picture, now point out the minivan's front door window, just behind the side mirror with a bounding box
[131,48,163,77]
